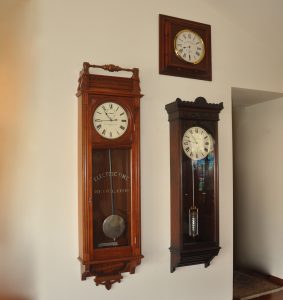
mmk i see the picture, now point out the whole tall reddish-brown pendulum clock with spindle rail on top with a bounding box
[77,63,143,289]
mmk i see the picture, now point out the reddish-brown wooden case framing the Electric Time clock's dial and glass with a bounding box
[77,63,143,289]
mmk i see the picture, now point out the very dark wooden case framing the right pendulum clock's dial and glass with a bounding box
[165,97,223,272]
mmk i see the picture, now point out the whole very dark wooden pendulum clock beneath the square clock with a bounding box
[165,97,223,272]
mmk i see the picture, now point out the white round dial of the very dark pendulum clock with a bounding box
[182,127,213,160]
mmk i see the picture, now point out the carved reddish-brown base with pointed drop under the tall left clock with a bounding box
[79,256,143,290]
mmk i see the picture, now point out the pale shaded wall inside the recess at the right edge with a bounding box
[233,98,283,278]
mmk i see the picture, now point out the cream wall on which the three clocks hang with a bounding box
[0,0,282,300]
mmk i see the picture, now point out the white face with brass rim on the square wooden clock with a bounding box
[174,29,205,64]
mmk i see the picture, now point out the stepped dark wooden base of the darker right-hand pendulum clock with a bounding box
[170,246,221,273]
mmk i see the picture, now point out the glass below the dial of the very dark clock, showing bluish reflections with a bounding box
[183,151,215,243]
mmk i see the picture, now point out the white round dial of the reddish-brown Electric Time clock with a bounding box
[93,102,129,139]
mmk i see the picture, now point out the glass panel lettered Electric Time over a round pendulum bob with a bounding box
[92,149,131,248]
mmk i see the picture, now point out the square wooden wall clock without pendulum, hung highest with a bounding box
[159,15,212,80]
